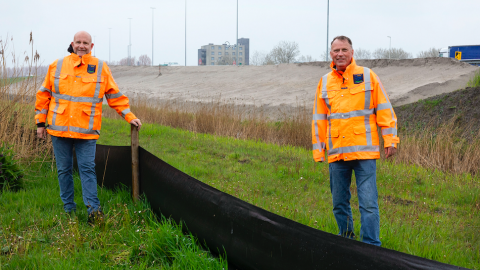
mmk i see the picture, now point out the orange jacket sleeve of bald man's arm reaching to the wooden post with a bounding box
[103,63,137,123]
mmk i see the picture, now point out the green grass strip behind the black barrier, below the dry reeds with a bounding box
[98,119,480,269]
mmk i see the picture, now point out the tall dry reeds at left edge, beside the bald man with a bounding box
[0,34,51,161]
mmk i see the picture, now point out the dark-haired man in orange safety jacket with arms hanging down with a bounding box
[312,36,400,246]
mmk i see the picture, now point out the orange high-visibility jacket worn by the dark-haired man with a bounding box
[312,59,400,163]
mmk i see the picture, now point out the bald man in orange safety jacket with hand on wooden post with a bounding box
[35,31,142,222]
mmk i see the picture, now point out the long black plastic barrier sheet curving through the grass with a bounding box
[95,145,465,270]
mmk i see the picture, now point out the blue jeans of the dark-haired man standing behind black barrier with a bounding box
[329,159,382,246]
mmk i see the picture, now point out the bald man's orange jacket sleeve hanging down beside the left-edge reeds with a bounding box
[35,60,54,125]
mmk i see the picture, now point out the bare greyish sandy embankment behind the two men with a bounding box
[111,58,478,108]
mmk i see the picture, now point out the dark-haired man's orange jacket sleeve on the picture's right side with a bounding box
[371,71,400,148]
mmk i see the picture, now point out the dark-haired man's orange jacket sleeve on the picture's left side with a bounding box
[312,79,328,162]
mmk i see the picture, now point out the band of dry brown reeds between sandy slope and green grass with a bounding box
[104,95,480,177]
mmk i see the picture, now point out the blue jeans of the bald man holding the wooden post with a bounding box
[51,136,100,214]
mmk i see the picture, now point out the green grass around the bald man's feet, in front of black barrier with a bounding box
[0,158,227,270]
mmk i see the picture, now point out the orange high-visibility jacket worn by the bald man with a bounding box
[35,53,136,139]
